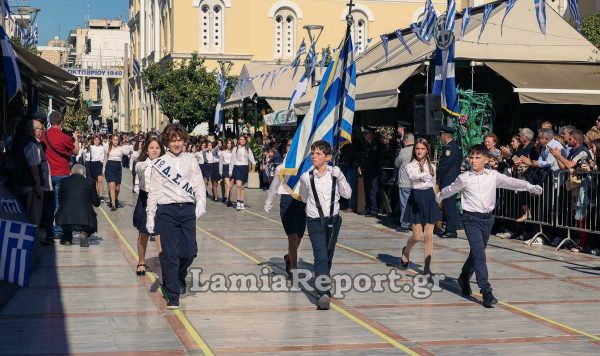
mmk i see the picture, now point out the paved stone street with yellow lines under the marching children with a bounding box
[0,173,600,355]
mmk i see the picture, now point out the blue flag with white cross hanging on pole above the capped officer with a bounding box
[431,41,460,116]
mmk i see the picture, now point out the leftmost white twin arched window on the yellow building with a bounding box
[200,0,225,53]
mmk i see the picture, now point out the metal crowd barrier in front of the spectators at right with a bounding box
[494,170,600,251]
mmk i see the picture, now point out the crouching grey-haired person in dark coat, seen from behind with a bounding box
[56,164,100,247]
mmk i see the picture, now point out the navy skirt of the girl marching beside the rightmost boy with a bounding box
[402,188,442,224]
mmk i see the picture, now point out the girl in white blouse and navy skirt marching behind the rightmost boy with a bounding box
[400,138,442,274]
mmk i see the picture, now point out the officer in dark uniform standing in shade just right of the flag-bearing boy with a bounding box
[359,128,381,217]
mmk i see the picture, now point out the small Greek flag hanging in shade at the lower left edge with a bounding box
[0,220,36,287]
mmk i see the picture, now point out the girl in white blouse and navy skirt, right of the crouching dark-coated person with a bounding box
[104,134,133,211]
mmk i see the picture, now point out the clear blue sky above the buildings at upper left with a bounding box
[8,0,129,46]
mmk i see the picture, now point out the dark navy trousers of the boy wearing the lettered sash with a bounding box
[154,203,198,298]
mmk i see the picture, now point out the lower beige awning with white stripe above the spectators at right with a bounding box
[485,62,600,105]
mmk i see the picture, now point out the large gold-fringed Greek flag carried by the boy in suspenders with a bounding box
[280,31,356,198]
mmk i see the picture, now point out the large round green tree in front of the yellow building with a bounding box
[143,53,230,129]
